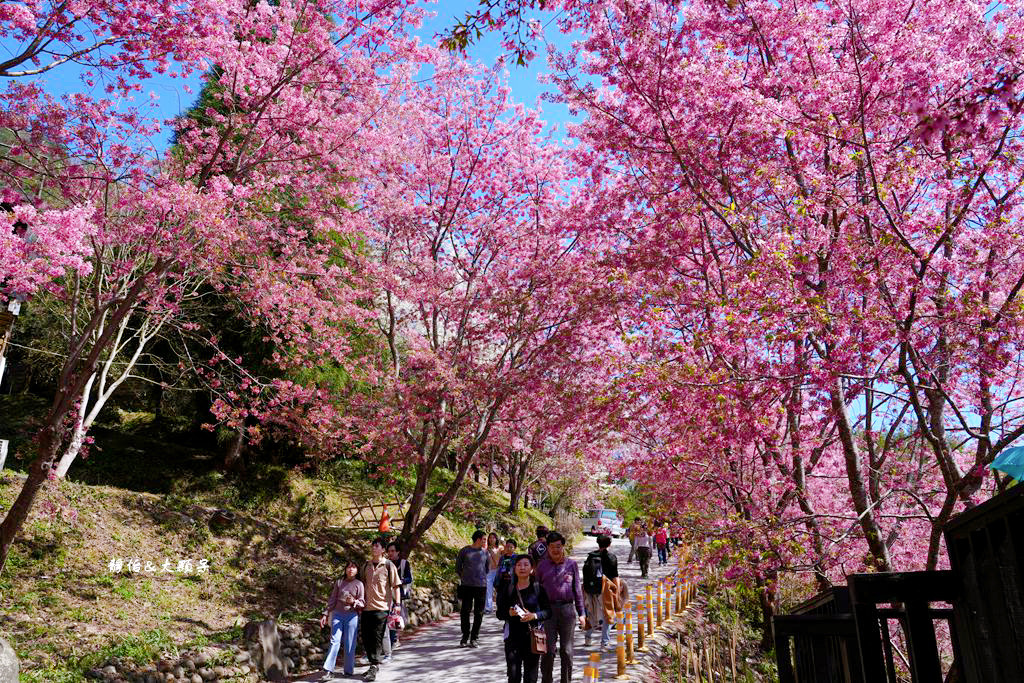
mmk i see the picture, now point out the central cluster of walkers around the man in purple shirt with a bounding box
[456,526,627,683]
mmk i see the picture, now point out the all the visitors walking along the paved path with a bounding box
[321,519,673,683]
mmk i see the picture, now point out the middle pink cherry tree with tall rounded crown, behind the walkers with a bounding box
[327,55,607,547]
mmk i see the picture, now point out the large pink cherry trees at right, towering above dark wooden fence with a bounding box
[540,1,1024,585]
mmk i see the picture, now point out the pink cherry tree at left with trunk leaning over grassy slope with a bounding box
[0,0,417,561]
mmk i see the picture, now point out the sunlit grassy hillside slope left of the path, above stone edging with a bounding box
[0,461,551,683]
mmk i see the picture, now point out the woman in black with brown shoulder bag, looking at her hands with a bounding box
[496,554,550,683]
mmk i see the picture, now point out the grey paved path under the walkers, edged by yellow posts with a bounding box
[297,537,676,683]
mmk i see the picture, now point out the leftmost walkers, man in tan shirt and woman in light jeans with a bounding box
[321,539,413,681]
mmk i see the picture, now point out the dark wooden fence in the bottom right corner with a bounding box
[774,485,1024,683]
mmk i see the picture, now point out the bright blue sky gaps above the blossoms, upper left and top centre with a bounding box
[0,0,571,151]
